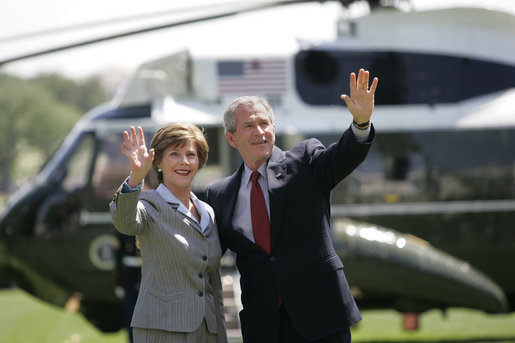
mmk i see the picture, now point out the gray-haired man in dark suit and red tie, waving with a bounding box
[206,69,378,343]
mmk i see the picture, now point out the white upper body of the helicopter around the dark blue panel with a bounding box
[110,4,515,133]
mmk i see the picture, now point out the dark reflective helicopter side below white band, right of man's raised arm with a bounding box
[332,129,515,204]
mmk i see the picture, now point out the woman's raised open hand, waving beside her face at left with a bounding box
[121,126,155,187]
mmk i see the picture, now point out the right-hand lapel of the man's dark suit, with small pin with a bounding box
[267,147,287,252]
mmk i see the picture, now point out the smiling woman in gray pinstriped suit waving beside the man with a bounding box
[110,124,227,343]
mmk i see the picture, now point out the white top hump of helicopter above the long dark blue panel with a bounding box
[328,7,515,64]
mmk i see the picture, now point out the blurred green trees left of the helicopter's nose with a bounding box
[0,73,109,193]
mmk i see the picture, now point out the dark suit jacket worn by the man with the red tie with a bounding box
[206,127,375,343]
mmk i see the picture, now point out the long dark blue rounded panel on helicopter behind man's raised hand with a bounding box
[295,50,515,106]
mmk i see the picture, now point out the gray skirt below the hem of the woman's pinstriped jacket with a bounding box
[132,319,218,343]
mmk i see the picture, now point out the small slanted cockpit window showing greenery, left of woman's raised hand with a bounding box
[62,134,95,192]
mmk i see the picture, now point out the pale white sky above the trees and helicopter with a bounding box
[0,0,515,79]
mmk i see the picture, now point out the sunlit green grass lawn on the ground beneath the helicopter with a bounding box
[0,289,515,343]
